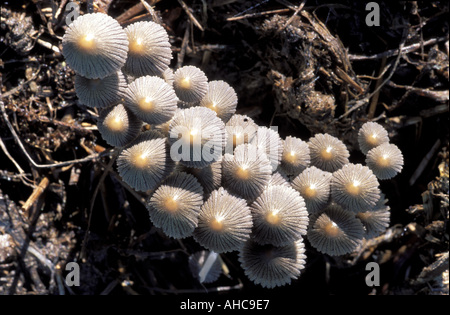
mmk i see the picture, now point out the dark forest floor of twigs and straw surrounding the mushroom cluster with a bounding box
[0,0,449,295]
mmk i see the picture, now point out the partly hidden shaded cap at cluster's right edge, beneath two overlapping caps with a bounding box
[356,194,391,239]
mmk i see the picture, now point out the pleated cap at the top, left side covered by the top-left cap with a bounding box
[123,21,172,77]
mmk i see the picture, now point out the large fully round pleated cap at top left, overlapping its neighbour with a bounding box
[62,13,128,79]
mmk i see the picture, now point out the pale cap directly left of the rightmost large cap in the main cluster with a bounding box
[291,166,332,213]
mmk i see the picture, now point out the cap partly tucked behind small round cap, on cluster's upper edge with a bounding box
[200,80,238,123]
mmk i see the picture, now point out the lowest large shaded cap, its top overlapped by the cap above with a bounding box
[239,239,306,289]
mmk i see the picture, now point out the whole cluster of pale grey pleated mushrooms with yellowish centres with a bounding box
[62,13,403,288]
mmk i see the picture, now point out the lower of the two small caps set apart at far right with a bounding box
[366,142,403,180]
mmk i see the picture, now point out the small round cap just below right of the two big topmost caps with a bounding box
[173,66,208,103]
